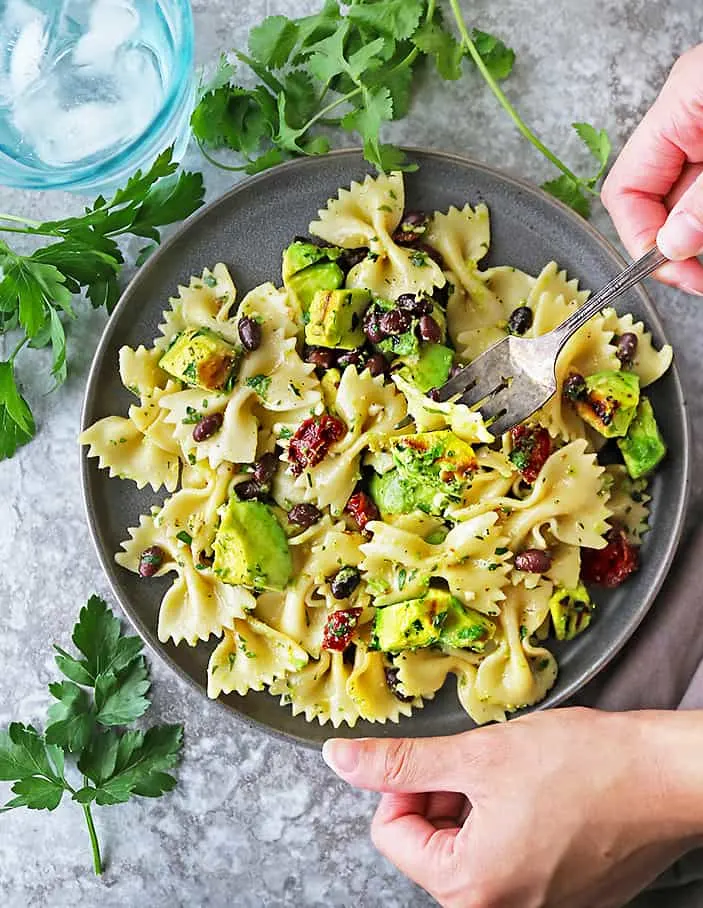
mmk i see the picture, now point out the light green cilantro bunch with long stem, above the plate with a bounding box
[192,0,611,217]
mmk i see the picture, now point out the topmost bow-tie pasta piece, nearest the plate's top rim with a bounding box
[310,172,446,299]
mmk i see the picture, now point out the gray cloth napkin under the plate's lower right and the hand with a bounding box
[569,515,703,908]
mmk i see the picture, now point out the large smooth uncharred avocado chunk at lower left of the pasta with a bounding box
[213,496,293,590]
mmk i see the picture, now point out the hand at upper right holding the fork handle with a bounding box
[601,44,703,296]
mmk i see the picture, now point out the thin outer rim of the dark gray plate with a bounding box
[80,145,692,751]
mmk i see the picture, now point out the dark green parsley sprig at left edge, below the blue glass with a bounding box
[0,149,204,460]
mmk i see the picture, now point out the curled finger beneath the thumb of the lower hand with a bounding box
[371,794,459,892]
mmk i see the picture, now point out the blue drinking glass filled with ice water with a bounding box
[0,0,195,192]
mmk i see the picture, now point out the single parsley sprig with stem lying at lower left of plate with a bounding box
[0,596,183,874]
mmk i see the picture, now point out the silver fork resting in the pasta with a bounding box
[435,247,668,436]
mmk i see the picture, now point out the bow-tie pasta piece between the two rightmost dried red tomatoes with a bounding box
[500,439,611,551]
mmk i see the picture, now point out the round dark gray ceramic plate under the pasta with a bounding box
[82,150,689,745]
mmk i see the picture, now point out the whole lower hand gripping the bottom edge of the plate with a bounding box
[323,708,703,908]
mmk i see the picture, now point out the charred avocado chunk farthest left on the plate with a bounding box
[159,328,241,391]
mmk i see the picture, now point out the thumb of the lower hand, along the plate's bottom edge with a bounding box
[322,734,470,794]
